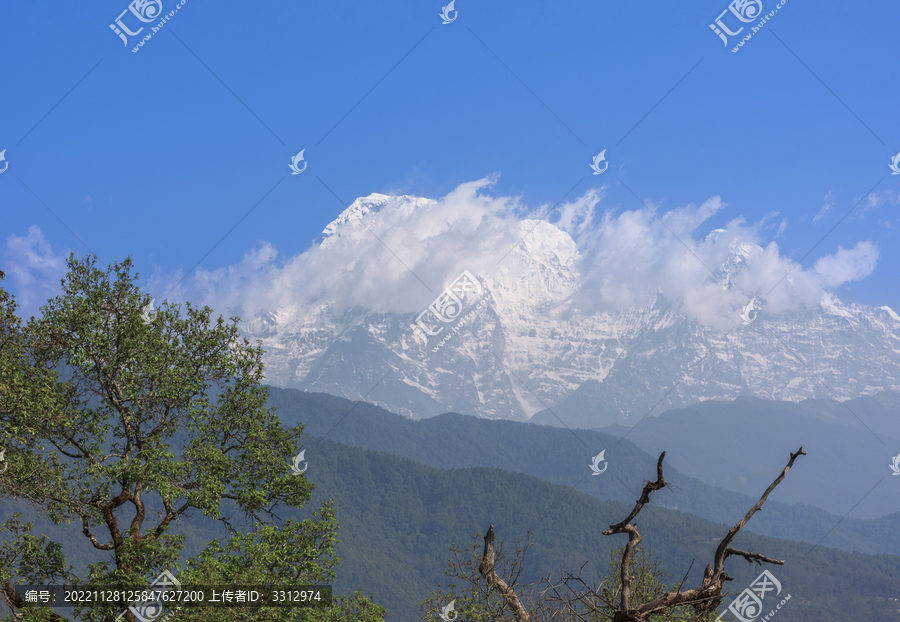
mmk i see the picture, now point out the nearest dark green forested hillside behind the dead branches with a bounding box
[2,436,900,622]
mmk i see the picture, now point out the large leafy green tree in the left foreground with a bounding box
[0,256,383,622]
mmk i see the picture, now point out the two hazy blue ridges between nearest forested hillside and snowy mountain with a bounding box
[269,388,900,555]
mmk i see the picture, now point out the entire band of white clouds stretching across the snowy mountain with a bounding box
[153,177,878,328]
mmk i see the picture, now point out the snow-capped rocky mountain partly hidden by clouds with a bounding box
[244,194,900,428]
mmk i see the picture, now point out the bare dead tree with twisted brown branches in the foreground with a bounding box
[479,447,806,622]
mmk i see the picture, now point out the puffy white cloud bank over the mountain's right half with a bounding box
[575,197,878,329]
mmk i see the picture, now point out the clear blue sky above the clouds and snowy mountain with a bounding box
[0,0,900,320]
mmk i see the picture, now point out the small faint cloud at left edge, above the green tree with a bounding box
[3,225,70,317]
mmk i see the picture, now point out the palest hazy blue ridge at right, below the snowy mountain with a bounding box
[601,396,900,518]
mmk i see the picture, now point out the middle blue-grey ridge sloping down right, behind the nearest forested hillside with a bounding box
[269,388,900,554]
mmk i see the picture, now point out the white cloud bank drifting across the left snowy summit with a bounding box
[171,178,528,317]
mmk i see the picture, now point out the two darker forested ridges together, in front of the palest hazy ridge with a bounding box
[0,388,900,622]
